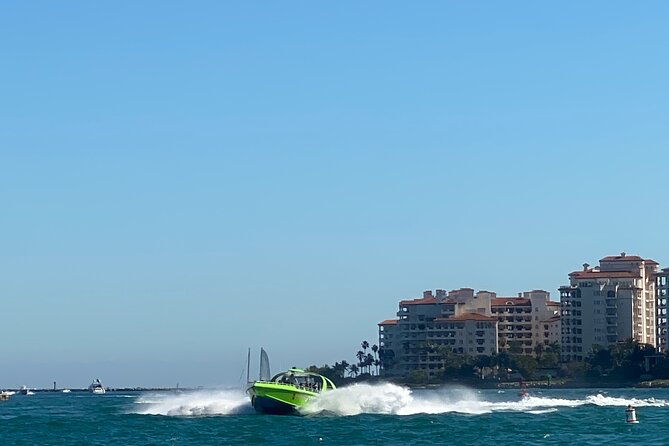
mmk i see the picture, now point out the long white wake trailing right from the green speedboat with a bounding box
[300,383,669,416]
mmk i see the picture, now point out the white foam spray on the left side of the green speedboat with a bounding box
[131,390,253,417]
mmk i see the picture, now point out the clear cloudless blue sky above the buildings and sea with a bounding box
[0,1,669,388]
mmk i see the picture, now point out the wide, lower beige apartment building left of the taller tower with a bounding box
[378,288,559,378]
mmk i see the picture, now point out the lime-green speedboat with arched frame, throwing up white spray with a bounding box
[247,368,335,415]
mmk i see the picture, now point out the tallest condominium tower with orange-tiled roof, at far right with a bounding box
[560,253,657,361]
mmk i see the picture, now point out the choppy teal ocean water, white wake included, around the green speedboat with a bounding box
[0,384,669,446]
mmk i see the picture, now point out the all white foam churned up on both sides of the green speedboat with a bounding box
[132,383,669,416]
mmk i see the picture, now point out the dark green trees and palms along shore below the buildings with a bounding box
[309,339,669,384]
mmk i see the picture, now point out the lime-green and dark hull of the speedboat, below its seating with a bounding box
[248,382,318,415]
